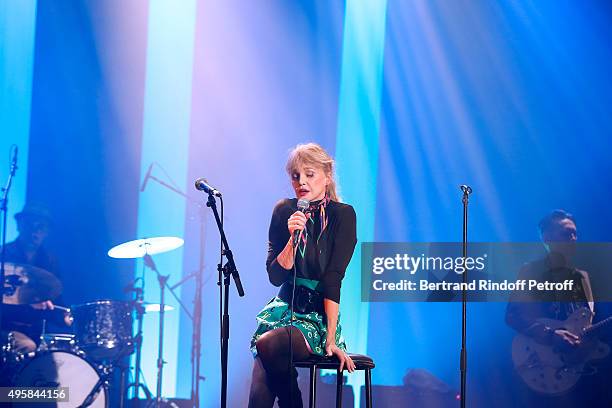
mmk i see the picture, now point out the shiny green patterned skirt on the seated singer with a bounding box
[251,278,346,357]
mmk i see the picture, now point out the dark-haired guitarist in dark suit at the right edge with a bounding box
[506,210,598,407]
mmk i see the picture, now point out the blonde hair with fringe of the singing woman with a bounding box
[285,143,341,202]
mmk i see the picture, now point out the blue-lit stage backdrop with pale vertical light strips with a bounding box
[0,0,612,407]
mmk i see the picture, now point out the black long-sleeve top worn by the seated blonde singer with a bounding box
[266,198,357,303]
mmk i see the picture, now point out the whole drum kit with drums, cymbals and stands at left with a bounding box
[0,237,183,408]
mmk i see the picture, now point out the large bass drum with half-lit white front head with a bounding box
[13,350,108,408]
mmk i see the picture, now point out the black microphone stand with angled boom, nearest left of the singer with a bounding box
[206,192,244,408]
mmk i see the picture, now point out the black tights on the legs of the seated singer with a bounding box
[249,327,310,408]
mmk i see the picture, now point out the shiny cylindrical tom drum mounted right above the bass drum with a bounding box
[72,300,134,360]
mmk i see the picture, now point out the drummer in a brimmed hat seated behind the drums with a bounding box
[1,204,70,353]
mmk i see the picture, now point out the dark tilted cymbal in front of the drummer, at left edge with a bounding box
[2,262,62,305]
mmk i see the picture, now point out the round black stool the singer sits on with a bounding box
[293,353,374,408]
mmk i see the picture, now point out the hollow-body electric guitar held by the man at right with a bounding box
[512,307,612,396]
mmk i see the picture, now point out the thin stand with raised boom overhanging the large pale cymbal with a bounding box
[145,167,205,408]
